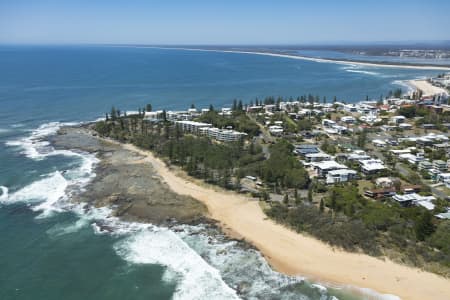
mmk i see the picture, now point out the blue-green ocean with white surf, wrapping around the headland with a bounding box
[0,46,437,300]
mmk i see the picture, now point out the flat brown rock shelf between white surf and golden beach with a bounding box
[51,125,209,225]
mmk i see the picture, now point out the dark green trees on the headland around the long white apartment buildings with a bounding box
[95,109,309,190]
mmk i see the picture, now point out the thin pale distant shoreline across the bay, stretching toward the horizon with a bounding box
[112,45,450,71]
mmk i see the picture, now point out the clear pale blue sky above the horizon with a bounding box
[0,0,450,44]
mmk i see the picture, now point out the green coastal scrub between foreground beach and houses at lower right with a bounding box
[266,183,450,276]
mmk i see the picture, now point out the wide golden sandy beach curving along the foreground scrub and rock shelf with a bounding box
[117,144,450,300]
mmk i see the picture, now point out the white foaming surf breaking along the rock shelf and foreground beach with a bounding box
[0,123,400,300]
